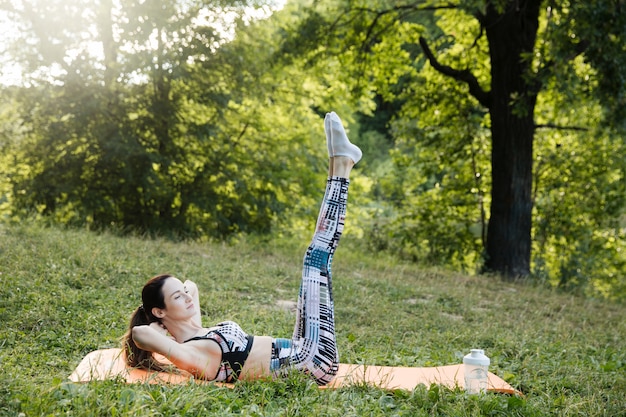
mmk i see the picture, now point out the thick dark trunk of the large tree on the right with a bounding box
[483,0,541,279]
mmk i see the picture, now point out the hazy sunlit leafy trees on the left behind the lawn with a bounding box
[2,0,332,237]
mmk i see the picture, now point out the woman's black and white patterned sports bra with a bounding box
[185,321,254,382]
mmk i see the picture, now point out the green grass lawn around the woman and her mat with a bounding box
[0,225,626,417]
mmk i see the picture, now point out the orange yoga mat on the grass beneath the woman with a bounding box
[69,348,521,395]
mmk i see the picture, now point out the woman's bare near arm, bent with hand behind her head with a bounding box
[132,322,222,380]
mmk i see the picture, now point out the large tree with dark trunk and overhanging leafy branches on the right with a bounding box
[288,0,626,278]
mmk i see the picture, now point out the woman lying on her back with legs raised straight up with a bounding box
[125,112,361,385]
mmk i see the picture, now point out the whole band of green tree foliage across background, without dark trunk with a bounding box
[0,0,626,299]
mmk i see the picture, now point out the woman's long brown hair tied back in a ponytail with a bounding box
[122,274,172,371]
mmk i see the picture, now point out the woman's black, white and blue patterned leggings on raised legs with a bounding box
[270,177,350,385]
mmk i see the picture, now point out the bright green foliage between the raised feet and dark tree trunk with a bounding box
[368,71,490,271]
